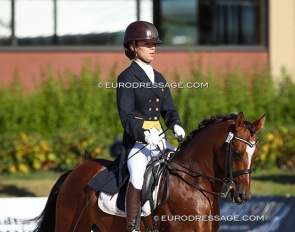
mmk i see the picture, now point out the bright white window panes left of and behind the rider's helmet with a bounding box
[0,0,152,46]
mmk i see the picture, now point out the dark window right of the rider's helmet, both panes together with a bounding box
[160,0,267,46]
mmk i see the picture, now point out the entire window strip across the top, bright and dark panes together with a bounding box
[0,0,268,47]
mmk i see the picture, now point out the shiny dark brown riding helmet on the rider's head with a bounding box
[123,21,162,60]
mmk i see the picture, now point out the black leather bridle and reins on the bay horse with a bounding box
[168,128,258,200]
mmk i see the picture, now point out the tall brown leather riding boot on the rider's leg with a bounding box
[126,182,141,232]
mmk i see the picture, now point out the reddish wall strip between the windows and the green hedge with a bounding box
[0,49,268,90]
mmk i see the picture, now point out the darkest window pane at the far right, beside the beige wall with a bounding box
[198,0,266,45]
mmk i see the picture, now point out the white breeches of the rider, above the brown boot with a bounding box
[127,139,175,189]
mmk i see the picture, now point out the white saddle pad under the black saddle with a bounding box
[98,179,159,217]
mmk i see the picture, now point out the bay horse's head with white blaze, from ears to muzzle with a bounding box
[225,112,265,204]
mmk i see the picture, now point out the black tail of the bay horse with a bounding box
[32,170,72,232]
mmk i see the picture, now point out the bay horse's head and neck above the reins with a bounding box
[170,112,265,207]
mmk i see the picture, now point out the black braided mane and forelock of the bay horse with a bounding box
[180,114,255,150]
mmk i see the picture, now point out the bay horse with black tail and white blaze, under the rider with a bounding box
[34,112,265,232]
